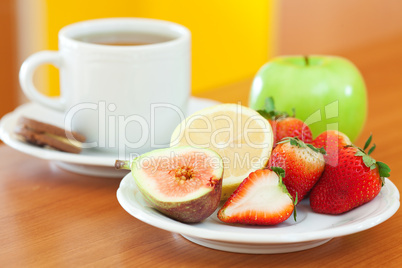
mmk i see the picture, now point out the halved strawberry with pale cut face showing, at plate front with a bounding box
[218,169,294,225]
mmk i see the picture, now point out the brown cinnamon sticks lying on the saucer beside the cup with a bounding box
[15,117,86,154]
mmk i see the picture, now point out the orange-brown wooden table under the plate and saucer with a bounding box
[0,36,402,267]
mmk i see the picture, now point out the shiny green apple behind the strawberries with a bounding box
[249,56,367,142]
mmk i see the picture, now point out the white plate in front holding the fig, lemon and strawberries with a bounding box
[117,174,399,254]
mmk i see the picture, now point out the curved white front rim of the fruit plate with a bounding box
[116,173,400,244]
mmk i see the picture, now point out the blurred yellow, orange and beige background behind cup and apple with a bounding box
[0,0,402,117]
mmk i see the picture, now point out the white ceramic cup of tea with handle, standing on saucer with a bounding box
[20,18,191,156]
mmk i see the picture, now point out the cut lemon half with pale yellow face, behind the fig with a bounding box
[170,103,273,200]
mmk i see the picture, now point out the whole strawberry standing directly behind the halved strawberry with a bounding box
[268,138,325,202]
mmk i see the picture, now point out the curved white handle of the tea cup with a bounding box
[19,50,65,111]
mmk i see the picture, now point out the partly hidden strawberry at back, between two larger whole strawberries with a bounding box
[311,130,352,166]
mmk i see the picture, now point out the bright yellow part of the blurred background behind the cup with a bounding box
[37,0,275,96]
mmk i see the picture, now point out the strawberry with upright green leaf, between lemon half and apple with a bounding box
[257,97,313,147]
